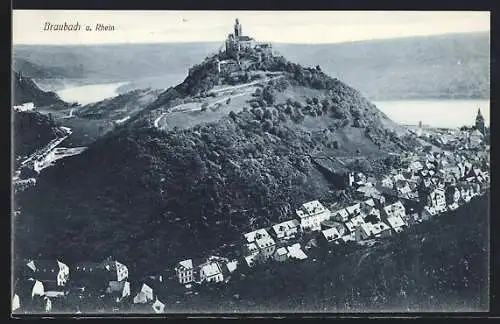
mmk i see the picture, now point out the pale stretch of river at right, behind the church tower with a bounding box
[374,99,490,128]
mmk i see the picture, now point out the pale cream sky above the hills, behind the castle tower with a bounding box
[12,10,490,45]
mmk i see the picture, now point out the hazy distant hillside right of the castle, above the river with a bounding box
[275,33,490,100]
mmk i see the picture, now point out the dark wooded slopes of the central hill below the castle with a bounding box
[16,52,411,271]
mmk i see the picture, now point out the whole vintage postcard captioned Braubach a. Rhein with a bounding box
[11,10,490,317]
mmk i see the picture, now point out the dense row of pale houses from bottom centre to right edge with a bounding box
[172,143,489,285]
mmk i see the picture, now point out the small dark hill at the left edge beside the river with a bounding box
[12,72,66,107]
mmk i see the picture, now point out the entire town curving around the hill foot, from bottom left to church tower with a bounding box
[12,107,490,314]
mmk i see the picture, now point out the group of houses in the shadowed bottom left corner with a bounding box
[12,258,165,313]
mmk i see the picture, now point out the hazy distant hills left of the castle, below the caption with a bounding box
[13,43,220,87]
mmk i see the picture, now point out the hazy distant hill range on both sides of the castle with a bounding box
[13,33,490,100]
